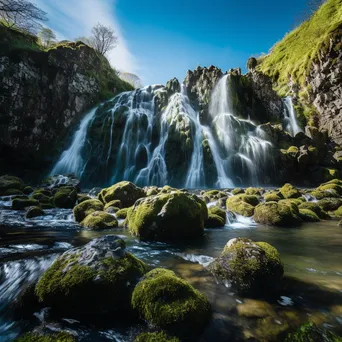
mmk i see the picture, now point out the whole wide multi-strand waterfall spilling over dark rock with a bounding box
[51,75,273,188]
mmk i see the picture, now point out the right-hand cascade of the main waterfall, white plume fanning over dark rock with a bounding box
[209,75,272,186]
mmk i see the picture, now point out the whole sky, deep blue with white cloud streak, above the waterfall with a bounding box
[35,0,308,84]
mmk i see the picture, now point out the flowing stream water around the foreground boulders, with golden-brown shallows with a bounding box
[0,196,342,342]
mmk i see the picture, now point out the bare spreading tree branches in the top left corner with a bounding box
[0,0,47,32]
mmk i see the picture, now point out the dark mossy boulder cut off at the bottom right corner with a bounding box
[285,323,342,342]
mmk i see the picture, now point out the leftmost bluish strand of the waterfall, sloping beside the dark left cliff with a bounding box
[50,108,97,177]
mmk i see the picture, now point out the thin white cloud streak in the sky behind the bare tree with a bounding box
[34,0,139,73]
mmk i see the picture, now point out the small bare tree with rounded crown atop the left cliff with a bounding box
[90,23,118,56]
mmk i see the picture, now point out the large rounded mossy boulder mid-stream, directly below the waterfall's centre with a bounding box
[126,191,208,241]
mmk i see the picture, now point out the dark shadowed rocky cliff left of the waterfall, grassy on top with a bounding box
[0,29,130,176]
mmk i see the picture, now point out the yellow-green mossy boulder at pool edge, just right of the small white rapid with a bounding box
[254,202,301,227]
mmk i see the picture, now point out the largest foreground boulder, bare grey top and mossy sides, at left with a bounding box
[36,235,147,315]
